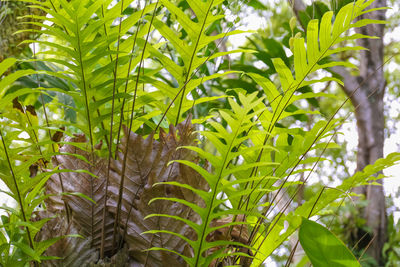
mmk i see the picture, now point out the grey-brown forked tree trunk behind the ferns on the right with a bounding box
[292,0,387,264]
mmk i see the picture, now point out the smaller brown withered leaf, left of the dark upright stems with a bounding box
[46,135,119,252]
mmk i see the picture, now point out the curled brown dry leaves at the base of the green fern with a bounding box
[41,119,208,266]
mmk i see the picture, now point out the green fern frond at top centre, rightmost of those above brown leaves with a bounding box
[154,0,250,124]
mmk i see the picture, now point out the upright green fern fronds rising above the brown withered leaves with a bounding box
[19,0,247,151]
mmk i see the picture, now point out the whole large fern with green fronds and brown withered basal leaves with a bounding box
[0,0,400,266]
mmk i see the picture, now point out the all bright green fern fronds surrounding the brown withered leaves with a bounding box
[0,0,394,266]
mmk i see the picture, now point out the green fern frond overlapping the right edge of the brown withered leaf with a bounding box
[148,93,275,266]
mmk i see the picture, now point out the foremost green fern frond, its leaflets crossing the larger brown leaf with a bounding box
[147,93,274,266]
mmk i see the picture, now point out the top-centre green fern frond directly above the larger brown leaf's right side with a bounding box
[142,0,245,124]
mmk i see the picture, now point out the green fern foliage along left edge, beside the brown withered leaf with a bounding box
[0,58,68,266]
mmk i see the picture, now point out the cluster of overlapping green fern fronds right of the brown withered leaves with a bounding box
[146,0,390,266]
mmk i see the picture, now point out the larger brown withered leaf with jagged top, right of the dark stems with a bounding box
[108,118,207,266]
